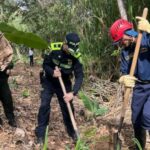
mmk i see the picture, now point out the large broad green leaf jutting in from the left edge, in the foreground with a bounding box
[0,23,48,49]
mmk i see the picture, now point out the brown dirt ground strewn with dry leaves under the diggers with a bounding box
[0,64,150,150]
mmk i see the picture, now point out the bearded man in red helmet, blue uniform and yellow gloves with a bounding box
[110,17,150,150]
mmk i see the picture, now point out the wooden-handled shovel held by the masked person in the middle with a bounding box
[57,67,80,139]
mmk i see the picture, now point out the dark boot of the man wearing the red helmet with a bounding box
[134,127,146,150]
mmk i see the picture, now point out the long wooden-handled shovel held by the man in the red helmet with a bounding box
[113,8,148,150]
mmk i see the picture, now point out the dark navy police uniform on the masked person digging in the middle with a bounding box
[35,49,83,138]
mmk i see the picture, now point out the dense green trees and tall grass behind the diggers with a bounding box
[0,0,150,79]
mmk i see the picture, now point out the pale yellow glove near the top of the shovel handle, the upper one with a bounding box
[136,17,150,33]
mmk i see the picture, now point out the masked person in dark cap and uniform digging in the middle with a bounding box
[35,33,83,143]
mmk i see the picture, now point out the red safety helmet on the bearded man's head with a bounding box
[110,19,133,42]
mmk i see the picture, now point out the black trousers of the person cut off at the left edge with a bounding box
[0,63,14,125]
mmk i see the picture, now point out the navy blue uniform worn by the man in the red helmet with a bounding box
[121,32,150,148]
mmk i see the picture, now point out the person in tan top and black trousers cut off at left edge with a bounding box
[0,33,17,127]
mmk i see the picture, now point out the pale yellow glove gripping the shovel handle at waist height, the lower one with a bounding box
[119,75,137,88]
